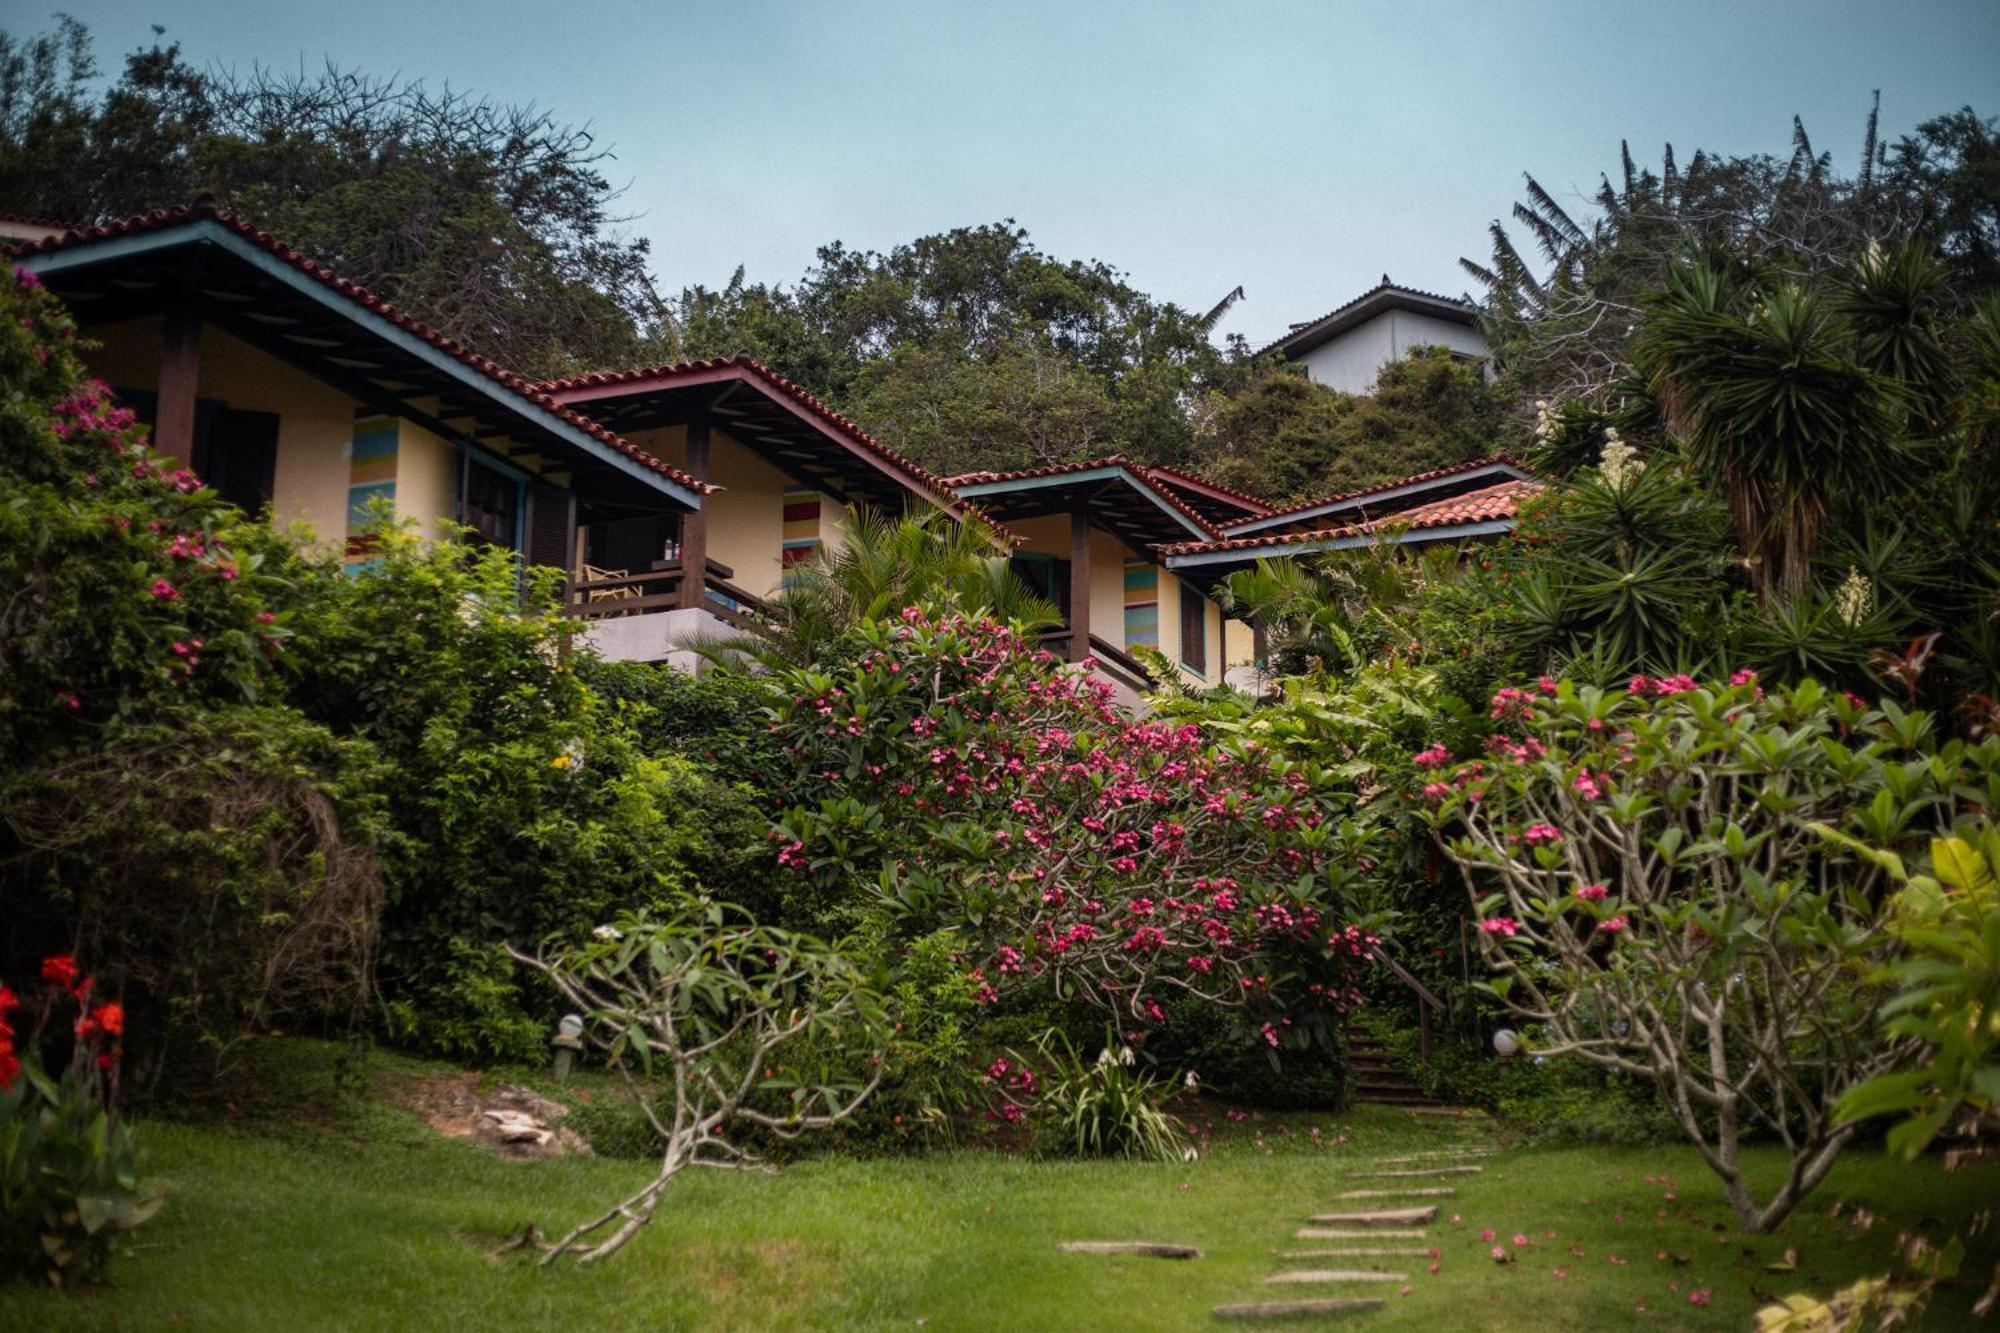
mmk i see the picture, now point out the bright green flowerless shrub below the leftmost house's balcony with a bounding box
[290,526,764,1059]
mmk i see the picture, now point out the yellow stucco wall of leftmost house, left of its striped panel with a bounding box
[84,318,358,546]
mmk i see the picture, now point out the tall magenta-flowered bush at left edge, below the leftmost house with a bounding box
[0,260,378,1085]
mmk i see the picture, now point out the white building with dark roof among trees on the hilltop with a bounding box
[1262,274,1488,394]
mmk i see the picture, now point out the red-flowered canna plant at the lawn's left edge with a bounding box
[0,955,160,1287]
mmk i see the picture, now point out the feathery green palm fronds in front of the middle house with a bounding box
[708,508,1062,667]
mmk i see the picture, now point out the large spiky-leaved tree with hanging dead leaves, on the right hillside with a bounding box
[1634,254,1912,596]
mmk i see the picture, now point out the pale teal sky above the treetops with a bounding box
[27,0,2000,340]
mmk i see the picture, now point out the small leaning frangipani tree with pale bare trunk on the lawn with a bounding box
[508,903,886,1265]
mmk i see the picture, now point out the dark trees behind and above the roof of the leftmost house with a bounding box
[0,18,664,376]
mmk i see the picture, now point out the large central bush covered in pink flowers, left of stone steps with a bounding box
[776,606,1372,1049]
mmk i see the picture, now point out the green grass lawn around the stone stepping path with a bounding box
[0,1040,2000,1333]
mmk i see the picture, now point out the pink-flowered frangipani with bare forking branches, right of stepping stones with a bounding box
[1430,673,2000,1231]
